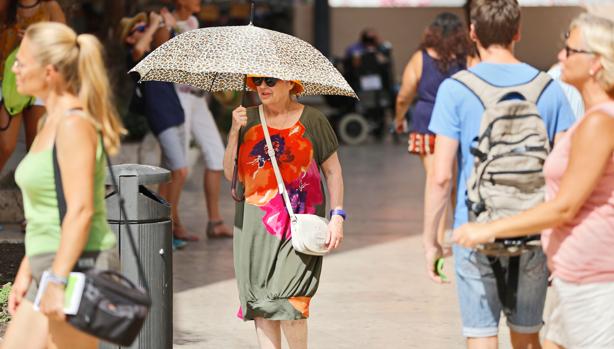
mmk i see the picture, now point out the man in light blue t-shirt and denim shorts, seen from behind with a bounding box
[423,0,574,349]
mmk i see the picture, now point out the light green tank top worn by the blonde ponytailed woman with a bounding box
[15,136,115,256]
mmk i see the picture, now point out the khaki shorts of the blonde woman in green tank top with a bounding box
[26,248,119,303]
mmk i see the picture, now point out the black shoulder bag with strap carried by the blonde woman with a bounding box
[53,137,151,346]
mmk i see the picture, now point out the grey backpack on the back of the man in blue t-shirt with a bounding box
[452,70,552,255]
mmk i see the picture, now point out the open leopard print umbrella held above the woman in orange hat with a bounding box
[130,25,356,98]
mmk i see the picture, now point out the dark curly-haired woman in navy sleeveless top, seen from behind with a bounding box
[395,12,469,249]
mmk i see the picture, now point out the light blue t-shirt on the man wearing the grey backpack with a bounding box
[429,63,574,228]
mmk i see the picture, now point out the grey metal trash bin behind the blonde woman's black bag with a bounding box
[100,164,173,349]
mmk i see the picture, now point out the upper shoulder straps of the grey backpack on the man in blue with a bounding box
[452,70,552,108]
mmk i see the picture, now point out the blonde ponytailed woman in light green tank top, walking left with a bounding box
[2,23,122,349]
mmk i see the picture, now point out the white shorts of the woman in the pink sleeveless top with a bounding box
[546,278,614,349]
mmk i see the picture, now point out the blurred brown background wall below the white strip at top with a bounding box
[294,5,583,78]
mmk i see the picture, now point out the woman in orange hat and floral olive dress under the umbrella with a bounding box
[224,76,345,348]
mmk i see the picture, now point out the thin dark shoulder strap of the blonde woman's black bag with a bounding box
[52,109,149,293]
